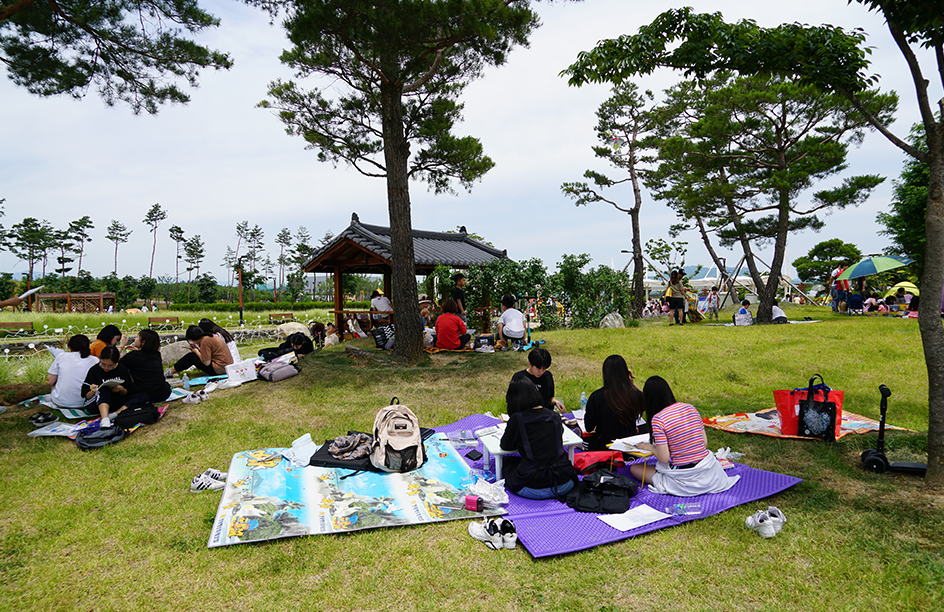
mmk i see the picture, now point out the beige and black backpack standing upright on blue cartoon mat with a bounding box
[370,398,426,472]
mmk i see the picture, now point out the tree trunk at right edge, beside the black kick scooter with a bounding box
[918,145,944,487]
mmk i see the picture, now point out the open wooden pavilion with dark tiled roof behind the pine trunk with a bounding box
[302,213,508,332]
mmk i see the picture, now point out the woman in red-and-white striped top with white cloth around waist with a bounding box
[629,376,741,497]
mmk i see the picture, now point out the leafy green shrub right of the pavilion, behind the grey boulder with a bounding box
[539,253,632,327]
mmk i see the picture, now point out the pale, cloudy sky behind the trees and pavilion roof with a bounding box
[0,0,942,282]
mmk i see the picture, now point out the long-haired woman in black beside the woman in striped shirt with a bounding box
[584,355,649,451]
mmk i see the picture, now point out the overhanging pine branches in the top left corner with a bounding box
[0,0,232,113]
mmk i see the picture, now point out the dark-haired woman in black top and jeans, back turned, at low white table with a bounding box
[499,378,577,499]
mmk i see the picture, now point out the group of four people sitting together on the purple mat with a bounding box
[500,348,737,499]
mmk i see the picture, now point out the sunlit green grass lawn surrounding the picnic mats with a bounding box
[0,307,944,612]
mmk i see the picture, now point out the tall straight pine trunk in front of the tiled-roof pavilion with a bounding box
[380,73,423,362]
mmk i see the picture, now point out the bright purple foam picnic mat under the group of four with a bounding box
[435,414,802,558]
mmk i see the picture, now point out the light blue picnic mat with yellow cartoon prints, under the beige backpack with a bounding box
[207,435,503,548]
